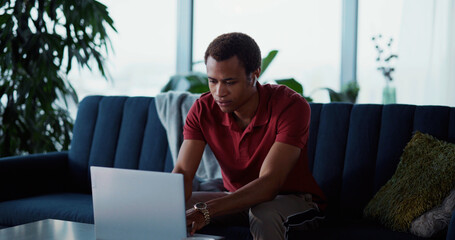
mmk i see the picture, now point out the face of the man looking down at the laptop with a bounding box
[207,56,259,113]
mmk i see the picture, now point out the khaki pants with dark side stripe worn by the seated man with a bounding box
[186,192,318,240]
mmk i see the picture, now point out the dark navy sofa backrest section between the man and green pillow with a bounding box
[308,103,455,219]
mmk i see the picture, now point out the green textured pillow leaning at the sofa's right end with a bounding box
[364,131,455,231]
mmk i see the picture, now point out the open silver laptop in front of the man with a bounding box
[90,167,223,240]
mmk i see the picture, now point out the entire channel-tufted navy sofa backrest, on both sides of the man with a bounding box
[69,96,455,219]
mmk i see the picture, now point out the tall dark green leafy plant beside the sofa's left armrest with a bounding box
[0,0,116,156]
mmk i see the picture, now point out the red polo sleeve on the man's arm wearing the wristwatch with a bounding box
[276,95,311,148]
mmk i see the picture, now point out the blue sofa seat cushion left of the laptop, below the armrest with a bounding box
[0,193,93,226]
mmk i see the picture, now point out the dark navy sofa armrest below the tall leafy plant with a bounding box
[0,152,68,202]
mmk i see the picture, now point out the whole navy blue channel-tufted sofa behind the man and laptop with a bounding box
[0,96,455,240]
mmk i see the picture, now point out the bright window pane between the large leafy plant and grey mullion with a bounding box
[69,0,177,99]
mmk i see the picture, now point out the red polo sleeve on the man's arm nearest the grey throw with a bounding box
[183,99,206,142]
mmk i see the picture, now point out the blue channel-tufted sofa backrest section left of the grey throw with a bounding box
[68,96,172,193]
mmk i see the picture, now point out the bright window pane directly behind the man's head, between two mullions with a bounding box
[193,0,341,101]
